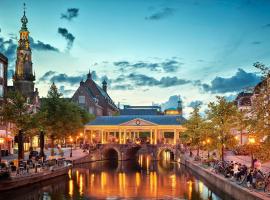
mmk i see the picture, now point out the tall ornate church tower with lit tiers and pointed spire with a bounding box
[13,4,35,101]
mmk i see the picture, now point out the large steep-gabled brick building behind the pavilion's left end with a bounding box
[71,71,119,116]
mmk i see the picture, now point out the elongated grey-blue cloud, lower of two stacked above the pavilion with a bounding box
[126,73,191,88]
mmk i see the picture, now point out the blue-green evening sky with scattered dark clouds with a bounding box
[0,0,270,114]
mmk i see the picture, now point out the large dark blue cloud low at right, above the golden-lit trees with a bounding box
[200,68,261,93]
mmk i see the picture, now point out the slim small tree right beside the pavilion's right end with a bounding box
[182,105,204,156]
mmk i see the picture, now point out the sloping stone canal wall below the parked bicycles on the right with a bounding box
[180,159,270,200]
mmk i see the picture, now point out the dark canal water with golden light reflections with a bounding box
[0,159,232,200]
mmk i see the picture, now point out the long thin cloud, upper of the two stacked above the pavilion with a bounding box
[113,59,184,73]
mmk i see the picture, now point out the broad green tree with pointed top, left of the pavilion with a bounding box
[41,83,91,155]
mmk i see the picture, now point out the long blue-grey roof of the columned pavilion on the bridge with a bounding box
[86,115,186,126]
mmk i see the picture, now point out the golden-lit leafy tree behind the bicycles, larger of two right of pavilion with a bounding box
[207,96,237,160]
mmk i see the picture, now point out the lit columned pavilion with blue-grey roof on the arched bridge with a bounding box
[84,115,185,144]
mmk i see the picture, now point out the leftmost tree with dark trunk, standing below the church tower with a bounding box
[0,91,33,159]
